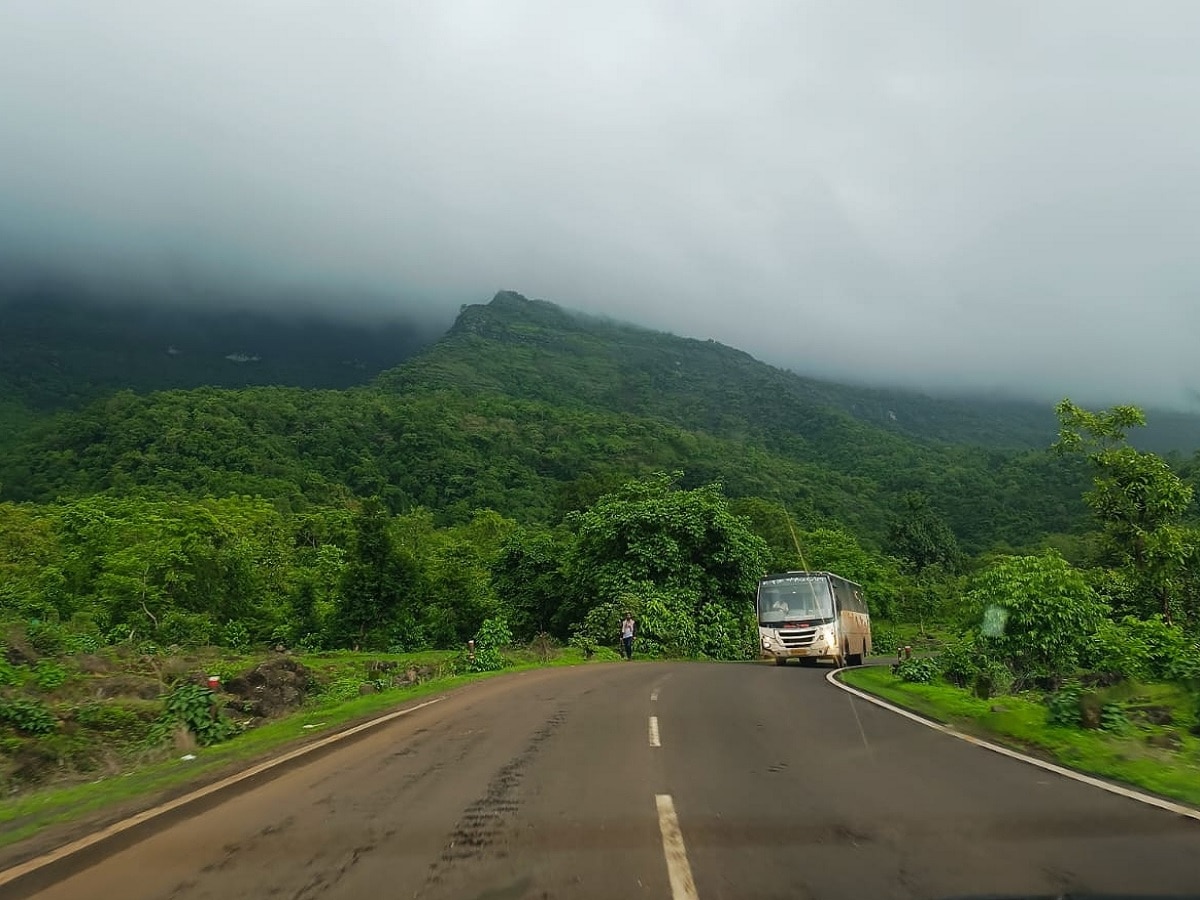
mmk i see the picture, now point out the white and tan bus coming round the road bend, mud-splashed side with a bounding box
[757,571,871,667]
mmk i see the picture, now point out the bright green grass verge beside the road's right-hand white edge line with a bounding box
[841,666,1200,806]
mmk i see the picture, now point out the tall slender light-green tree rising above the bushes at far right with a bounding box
[1055,400,1194,622]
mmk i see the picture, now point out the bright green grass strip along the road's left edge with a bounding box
[0,648,595,847]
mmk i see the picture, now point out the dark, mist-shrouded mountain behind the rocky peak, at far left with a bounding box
[0,293,440,412]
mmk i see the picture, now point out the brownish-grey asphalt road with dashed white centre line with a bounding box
[16,664,1200,900]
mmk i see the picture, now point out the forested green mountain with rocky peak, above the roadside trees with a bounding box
[0,293,1099,551]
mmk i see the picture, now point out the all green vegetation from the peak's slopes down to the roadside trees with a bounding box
[0,293,1200,786]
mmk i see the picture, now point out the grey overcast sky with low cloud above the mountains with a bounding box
[0,0,1200,404]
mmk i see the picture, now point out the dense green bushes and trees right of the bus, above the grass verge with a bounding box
[878,401,1200,768]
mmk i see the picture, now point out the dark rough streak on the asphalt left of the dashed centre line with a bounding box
[426,709,566,888]
